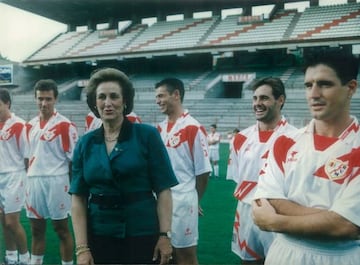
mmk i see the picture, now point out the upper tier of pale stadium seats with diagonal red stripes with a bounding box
[25,3,360,64]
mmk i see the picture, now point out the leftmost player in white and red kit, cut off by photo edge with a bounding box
[0,89,30,265]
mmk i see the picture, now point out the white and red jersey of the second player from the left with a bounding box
[26,111,78,176]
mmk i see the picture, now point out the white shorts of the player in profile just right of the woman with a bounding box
[171,190,199,248]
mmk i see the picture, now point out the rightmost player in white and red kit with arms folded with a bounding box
[253,50,360,265]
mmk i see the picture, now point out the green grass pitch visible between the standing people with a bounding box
[0,144,241,265]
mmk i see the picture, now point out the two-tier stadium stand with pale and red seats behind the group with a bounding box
[1,0,360,134]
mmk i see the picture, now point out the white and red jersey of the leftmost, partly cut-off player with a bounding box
[0,113,26,173]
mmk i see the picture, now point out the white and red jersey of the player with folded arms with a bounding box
[255,117,360,226]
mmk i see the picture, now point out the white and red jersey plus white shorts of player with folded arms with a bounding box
[254,117,360,265]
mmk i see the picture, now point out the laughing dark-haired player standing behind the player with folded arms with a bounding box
[227,77,296,264]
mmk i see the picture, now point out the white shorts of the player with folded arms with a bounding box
[265,234,360,265]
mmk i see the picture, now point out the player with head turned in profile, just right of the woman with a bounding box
[155,78,211,265]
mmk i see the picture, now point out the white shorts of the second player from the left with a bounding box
[26,174,71,220]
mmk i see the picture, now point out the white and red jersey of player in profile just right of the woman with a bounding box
[158,110,211,192]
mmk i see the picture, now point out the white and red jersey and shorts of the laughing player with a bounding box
[227,117,296,260]
